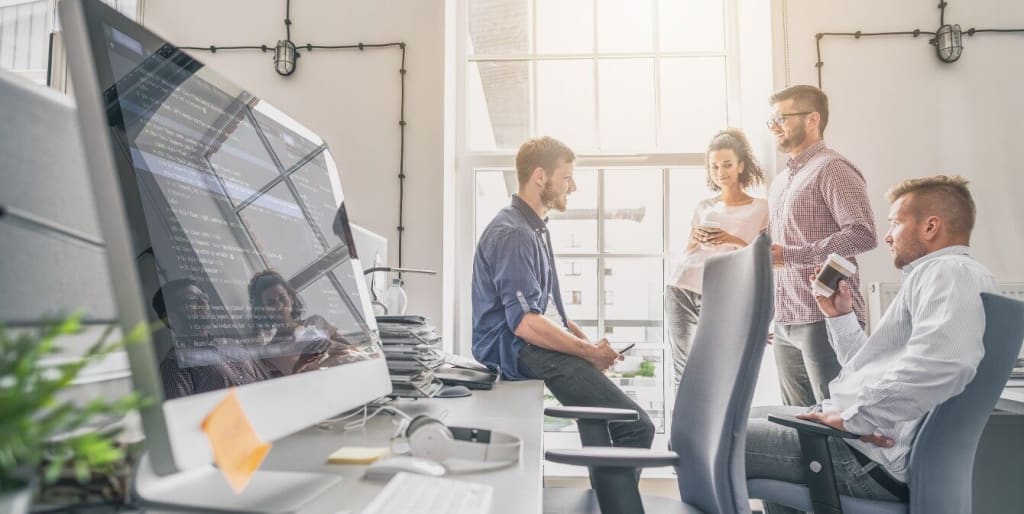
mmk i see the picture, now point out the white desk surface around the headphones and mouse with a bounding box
[263,381,544,514]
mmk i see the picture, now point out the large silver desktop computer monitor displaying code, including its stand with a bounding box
[60,0,391,511]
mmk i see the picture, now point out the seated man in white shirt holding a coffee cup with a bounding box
[746,175,996,514]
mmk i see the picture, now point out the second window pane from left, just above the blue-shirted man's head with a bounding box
[537,59,596,153]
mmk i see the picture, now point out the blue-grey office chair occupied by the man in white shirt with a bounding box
[746,293,1024,514]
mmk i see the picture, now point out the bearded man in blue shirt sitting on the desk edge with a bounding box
[473,137,654,447]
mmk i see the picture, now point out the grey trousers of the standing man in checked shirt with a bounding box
[774,320,842,406]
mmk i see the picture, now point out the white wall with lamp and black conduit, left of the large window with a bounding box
[142,0,445,326]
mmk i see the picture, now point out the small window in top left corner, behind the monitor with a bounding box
[0,0,138,84]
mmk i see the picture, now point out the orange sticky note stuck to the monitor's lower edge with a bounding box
[203,388,270,492]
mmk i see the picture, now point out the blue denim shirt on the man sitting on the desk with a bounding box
[473,195,567,380]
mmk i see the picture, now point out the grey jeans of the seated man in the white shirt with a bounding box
[746,406,898,514]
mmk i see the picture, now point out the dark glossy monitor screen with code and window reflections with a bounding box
[92,24,381,398]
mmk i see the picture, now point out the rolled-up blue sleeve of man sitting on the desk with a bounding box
[488,228,544,332]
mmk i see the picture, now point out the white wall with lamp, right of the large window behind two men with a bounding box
[766,0,1024,283]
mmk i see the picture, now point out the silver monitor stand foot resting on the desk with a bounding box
[133,454,342,514]
